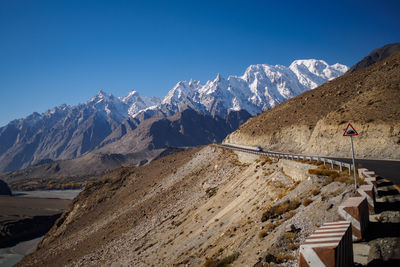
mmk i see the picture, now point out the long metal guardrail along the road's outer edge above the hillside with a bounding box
[218,144,354,175]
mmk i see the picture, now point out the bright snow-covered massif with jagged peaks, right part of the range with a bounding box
[134,59,348,117]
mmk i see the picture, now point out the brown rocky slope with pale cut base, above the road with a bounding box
[224,50,400,159]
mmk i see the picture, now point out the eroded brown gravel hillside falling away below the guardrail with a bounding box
[19,146,352,266]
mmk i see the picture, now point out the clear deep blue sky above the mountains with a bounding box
[0,0,400,126]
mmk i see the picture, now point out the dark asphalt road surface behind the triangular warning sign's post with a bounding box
[331,158,400,185]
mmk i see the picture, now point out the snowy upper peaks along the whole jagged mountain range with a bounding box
[13,59,348,130]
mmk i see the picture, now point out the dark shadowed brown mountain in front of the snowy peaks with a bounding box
[98,109,251,154]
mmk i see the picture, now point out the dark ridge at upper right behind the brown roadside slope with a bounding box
[348,43,400,73]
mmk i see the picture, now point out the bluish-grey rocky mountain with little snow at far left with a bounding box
[0,91,158,171]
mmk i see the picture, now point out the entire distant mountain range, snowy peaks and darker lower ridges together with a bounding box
[0,59,348,171]
